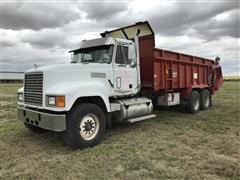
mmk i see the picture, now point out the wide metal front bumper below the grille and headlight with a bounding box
[18,107,66,132]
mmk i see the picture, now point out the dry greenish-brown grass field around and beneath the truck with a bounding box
[0,82,240,179]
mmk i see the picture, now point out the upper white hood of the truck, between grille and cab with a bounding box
[26,63,112,91]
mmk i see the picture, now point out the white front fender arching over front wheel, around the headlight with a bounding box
[45,81,111,112]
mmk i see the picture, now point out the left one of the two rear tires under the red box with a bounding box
[186,90,200,114]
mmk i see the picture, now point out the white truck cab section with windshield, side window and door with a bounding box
[70,37,138,97]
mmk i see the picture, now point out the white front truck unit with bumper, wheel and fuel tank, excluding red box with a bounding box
[18,26,155,148]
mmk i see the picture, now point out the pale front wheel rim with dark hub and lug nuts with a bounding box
[80,114,99,141]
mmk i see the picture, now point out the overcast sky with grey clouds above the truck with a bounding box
[0,0,240,75]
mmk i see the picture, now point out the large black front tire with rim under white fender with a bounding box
[64,103,106,149]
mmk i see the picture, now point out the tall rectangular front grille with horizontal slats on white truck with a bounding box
[24,72,43,106]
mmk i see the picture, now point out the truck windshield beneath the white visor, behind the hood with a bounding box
[71,45,113,63]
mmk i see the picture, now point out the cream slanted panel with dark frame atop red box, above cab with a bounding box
[101,21,154,39]
